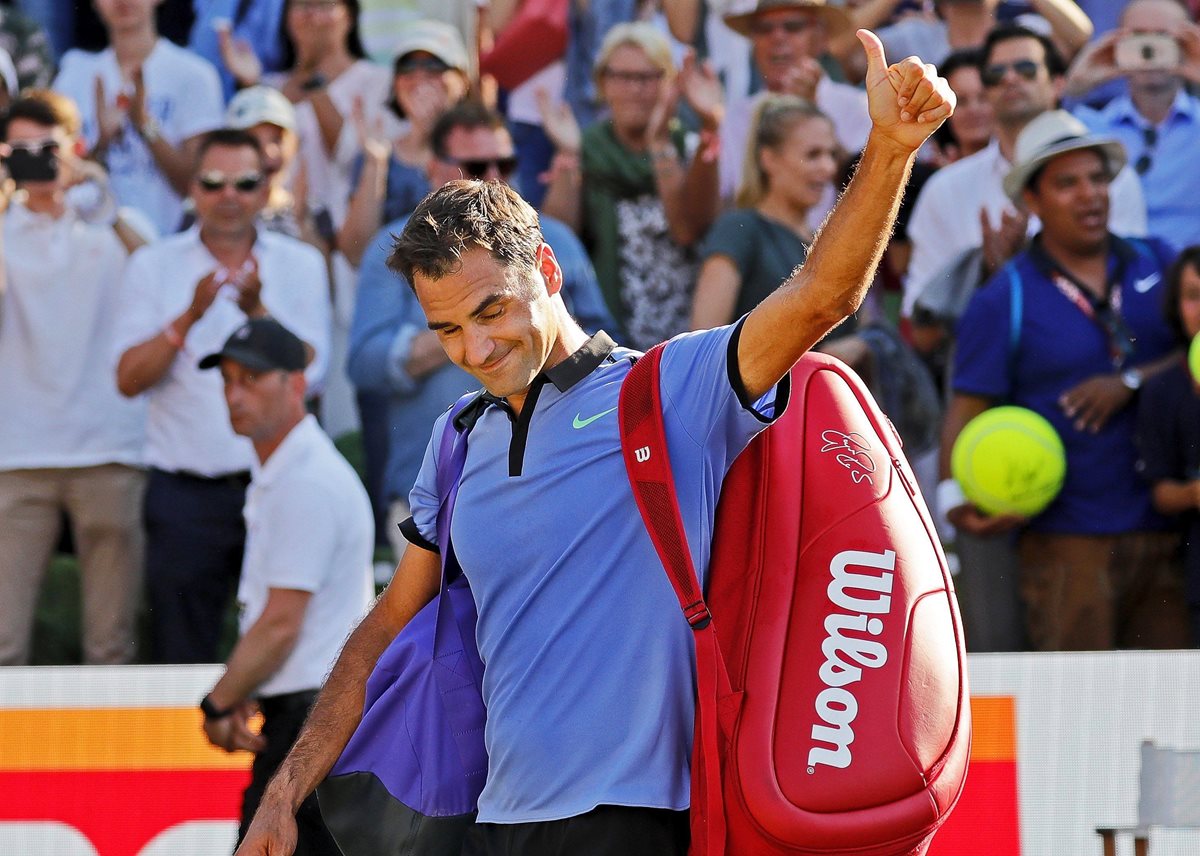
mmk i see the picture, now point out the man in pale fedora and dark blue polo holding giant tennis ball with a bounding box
[938,110,1188,651]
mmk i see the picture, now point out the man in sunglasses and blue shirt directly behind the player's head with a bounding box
[348,102,616,556]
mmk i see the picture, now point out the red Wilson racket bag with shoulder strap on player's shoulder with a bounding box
[620,346,971,856]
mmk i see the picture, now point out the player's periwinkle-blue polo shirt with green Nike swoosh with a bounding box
[404,324,786,824]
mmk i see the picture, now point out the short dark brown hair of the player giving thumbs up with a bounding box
[388,180,544,286]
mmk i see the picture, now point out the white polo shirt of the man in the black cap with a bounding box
[238,415,374,698]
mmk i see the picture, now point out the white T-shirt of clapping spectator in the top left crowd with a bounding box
[54,38,224,234]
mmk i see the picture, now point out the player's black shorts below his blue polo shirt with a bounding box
[462,806,690,856]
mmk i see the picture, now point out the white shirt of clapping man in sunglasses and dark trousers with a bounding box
[115,227,331,475]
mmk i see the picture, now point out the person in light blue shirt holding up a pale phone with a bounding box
[1067,0,1200,250]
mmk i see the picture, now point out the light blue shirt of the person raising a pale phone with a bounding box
[1075,90,1200,250]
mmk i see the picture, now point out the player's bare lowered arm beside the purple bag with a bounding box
[236,545,442,856]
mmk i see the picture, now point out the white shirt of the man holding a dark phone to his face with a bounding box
[0,194,145,469]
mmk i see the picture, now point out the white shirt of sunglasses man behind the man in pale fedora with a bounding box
[901,140,1147,316]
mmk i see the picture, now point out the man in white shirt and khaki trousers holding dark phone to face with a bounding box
[0,89,145,665]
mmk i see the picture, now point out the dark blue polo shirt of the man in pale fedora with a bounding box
[954,238,1175,534]
